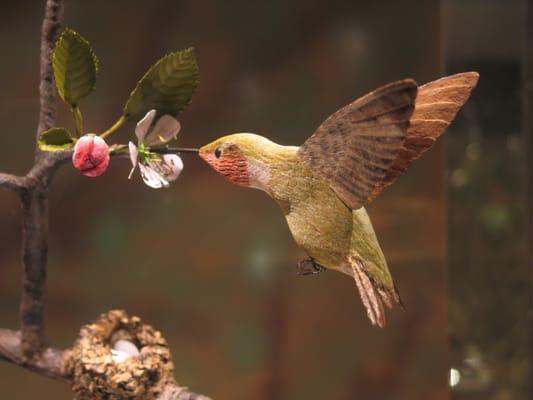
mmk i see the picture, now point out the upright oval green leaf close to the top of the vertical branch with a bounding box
[52,28,98,106]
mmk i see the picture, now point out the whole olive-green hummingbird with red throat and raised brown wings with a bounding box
[199,72,479,327]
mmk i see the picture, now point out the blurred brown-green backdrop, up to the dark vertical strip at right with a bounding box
[0,0,518,400]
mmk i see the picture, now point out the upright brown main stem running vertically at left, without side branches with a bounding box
[20,0,63,360]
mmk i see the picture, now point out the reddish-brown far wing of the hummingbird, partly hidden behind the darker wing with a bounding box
[369,72,479,201]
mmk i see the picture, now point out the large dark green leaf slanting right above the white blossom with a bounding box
[124,48,200,120]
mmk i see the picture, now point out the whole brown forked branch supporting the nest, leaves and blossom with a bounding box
[0,0,209,400]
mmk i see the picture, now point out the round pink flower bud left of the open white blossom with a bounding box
[72,134,109,177]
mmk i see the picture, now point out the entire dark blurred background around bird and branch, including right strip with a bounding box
[0,0,529,400]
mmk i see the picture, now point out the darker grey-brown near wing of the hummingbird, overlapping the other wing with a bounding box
[298,79,417,210]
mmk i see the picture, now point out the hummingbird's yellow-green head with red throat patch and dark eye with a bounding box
[199,133,283,189]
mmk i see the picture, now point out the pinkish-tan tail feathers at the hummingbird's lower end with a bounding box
[351,261,403,328]
